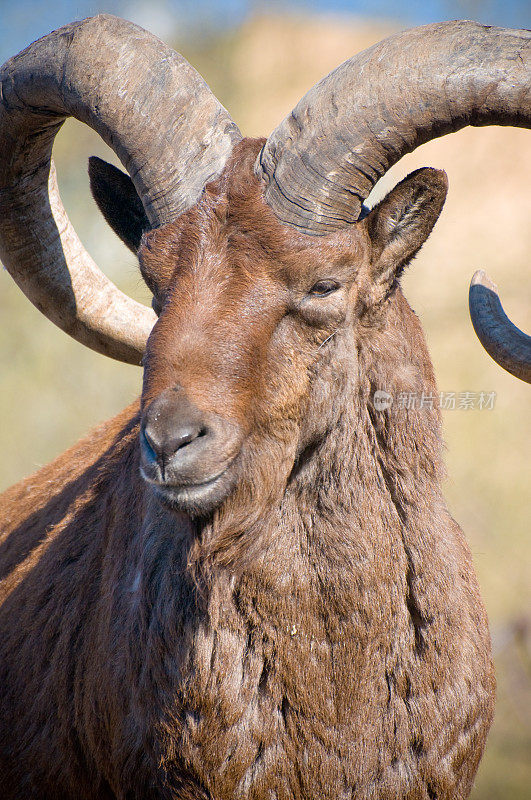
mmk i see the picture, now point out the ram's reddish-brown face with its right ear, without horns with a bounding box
[93,141,446,515]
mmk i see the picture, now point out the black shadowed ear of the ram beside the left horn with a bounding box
[89,156,149,254]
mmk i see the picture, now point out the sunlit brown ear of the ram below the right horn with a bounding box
[367,167,448,293]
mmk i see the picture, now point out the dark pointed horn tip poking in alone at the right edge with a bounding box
[468,270,531,383]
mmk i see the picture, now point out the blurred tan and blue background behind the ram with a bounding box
[0,0,531,800]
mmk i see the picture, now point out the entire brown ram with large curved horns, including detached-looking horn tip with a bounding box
[0,15,531,800]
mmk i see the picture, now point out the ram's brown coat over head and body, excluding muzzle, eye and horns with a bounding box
[0,141,494,800]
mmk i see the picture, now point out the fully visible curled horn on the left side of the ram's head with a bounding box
[0,14,241,364]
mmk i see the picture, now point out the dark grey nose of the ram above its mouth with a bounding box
[143,392,209,474]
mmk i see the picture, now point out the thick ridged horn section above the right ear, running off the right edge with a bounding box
[255,21,531,235]
